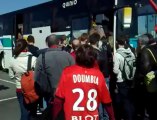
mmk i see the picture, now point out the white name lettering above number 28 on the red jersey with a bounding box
[73,74,99,85]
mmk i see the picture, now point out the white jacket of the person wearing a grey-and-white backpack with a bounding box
[113,48,134,82]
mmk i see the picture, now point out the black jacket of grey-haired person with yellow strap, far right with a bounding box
[135,45,157,85]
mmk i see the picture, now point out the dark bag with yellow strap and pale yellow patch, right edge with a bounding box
[144,48,157,93]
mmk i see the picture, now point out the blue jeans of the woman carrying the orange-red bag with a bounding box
[16,92,29,120]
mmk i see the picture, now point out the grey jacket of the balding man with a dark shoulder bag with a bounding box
[34,48,75,88]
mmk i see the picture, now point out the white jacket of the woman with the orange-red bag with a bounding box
[9,52,36,89]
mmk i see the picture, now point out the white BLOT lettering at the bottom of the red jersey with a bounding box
[71,115,98,120]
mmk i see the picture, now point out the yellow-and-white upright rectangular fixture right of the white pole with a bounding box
[123,7,132,28]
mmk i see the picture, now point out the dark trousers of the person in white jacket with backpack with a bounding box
[115,82,135,120]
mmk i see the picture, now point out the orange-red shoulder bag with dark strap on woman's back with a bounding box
[21,55,39,104]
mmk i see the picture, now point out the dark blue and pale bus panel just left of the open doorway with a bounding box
[71,17,90,39]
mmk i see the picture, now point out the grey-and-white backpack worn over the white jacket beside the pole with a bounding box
[118,51,136,80]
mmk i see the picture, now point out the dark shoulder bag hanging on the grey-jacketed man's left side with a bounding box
[35,52,53,97]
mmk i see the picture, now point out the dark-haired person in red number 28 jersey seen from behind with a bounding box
[52,45,115,120]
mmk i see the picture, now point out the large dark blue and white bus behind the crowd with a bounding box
[0,0,148,70]
